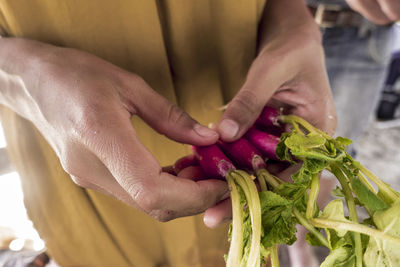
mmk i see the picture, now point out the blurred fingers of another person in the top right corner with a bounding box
[346,0,400,25]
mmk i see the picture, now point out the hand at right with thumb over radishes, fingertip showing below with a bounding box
[204,2,336,227]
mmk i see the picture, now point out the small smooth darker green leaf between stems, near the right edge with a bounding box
[351,177,389,213]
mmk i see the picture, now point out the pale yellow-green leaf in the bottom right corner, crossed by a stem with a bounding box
[364,201,400,266]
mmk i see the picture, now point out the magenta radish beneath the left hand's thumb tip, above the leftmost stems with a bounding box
[192,144,235,178]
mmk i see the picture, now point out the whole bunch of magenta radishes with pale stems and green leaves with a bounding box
[174,107,400,267]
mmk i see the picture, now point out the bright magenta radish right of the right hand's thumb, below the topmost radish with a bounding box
[246,127,280,160]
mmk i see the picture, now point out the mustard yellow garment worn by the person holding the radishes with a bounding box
[0,0,265,267]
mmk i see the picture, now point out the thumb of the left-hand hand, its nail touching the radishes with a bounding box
[134,80,219,146]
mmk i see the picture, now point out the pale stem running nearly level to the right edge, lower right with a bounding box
[310,218,400,245]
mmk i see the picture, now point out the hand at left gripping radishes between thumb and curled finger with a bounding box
[0,38,229,221]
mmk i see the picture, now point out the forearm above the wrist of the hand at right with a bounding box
[259,0,321,50]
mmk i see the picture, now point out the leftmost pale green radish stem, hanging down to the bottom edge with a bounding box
[226,174,244,267]
